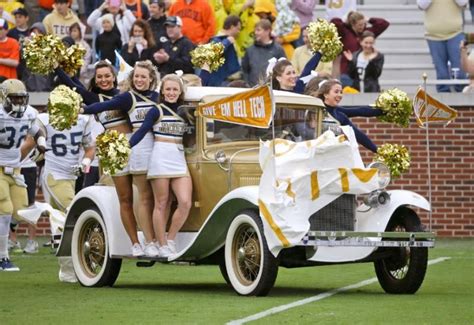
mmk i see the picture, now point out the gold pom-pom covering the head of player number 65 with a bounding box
[48,85,82,131]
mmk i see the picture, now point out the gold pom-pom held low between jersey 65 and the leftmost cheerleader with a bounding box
[96,130,132,175]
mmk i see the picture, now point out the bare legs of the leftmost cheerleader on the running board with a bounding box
[112,175,139,245]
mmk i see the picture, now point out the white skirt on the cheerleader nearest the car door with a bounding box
[147,141,189,179]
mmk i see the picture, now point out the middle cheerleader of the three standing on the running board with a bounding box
[84,61,158,257]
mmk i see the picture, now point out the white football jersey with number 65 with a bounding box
[38,113,93,180]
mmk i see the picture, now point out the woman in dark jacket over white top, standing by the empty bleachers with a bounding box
[343,31,384,93]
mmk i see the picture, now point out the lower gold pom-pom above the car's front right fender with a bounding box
[374,143,411,177]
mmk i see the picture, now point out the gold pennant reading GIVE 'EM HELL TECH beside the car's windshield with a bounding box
[198,85,273,129]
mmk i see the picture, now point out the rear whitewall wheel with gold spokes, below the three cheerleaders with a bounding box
[71,209,122,287]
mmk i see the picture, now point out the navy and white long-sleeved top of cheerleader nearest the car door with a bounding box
[130,102,186,147]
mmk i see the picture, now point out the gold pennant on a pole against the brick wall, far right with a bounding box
[413,88,458,127]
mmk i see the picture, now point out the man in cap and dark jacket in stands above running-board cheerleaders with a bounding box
[152,16,194,76]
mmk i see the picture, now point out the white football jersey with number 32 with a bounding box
[0,105,37,168]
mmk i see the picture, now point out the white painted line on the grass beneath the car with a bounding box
[227,257,451,325]
